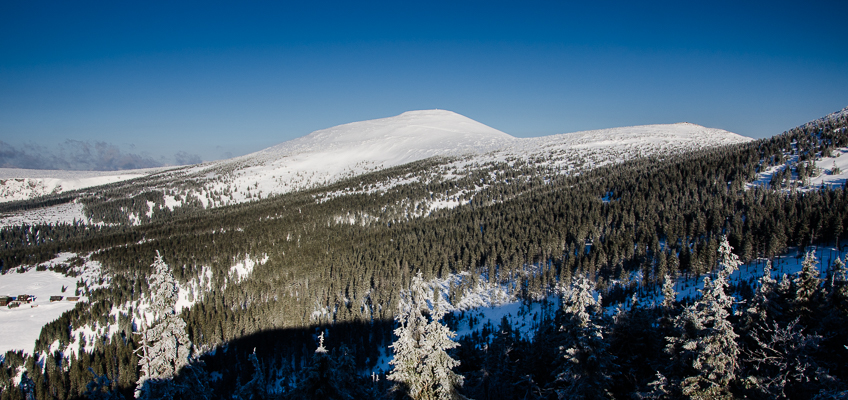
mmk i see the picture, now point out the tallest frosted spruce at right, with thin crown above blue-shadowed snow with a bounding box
[666,237,741,399]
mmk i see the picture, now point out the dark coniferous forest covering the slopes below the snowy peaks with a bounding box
[0,108,848,400]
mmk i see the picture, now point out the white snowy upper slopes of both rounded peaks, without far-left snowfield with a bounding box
[177,110,751,204]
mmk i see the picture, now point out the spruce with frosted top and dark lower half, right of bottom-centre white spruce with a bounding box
[552,276,616,399]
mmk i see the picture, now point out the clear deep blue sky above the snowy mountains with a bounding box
[0,0,848,168]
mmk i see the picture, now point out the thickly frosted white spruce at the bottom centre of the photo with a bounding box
[388,271,464,400]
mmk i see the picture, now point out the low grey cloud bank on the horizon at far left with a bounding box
[0,139,202,171]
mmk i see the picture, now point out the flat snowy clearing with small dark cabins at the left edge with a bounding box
[0,253,101,354]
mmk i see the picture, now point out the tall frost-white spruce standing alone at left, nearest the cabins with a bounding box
[135,251,191,399]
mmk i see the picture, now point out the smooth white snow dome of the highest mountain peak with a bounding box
[181,110,517,203]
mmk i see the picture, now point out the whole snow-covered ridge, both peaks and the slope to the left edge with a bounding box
[0,110,750,226]
